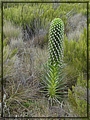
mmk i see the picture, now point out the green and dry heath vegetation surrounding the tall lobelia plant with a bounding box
[0,0,90,120]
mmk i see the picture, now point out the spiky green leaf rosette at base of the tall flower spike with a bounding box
[42,63,66,102]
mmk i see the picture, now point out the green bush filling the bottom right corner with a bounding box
[68,77,87,117]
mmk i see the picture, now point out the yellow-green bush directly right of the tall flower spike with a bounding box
[64,29,87,85]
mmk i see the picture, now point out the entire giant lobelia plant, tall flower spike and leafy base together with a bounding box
[40,18,66,105]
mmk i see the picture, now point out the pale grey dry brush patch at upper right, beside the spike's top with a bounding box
[66,13,87,40]
